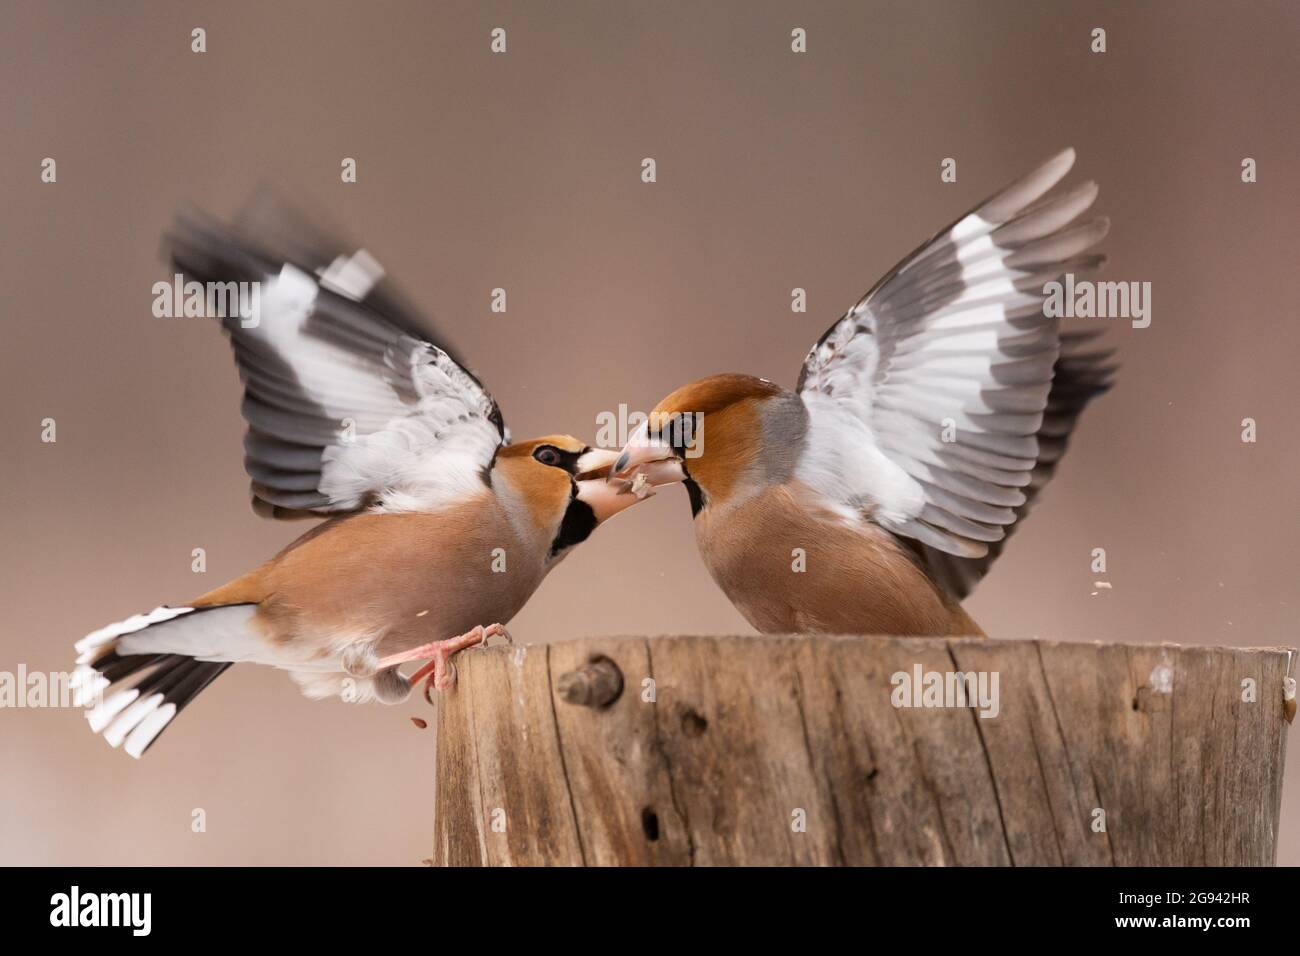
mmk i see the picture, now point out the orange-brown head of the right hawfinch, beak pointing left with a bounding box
[610,375,798,514]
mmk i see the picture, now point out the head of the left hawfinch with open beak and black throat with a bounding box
[493,434,660,557]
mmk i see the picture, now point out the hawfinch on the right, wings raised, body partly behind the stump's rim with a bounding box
[612,150,1114,635]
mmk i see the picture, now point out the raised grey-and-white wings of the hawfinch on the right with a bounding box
[798,150,1110,567]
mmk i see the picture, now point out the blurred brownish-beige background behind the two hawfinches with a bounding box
[0,0,1300,865]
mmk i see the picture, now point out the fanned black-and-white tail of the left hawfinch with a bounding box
[72,604,256,757]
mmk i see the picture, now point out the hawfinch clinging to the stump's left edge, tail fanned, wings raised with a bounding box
[73,198,651,757]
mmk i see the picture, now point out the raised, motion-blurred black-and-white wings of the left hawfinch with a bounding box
[165,193,510,518]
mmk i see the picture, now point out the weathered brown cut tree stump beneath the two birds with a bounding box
[433,636,1290,866]
